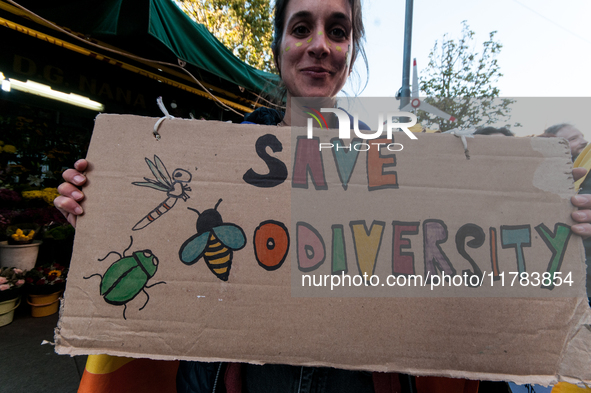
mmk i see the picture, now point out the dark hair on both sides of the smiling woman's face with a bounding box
[271,0,368,95]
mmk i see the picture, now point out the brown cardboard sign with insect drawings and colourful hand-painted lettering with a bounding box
[56,115,591,383]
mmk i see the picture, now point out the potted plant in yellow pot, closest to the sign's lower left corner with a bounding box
[25,263,68,317]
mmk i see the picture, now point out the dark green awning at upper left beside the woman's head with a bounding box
[13,0,279,93]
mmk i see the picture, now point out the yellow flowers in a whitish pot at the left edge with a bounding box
[0,224,42,270]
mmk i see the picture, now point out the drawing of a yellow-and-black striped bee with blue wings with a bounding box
[179,199,246,281]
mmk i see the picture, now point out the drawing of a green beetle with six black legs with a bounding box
[84,236,166,319]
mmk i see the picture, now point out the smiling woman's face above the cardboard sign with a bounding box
[277,0,353,97]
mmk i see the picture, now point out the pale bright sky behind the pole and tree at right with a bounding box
[345,0,591,140]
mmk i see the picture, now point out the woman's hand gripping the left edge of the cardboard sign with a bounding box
[53,159,88,227]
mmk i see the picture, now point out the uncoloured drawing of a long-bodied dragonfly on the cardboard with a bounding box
[132,155,192,231]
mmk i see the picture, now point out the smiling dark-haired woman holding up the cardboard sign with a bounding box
[55,0,591,392]
